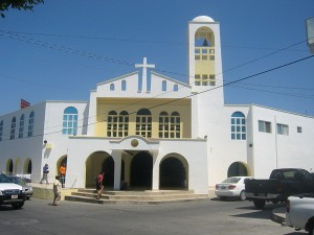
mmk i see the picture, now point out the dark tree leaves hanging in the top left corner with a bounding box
[0,0,44,18]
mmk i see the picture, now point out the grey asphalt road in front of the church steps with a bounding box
[0,199,305,235]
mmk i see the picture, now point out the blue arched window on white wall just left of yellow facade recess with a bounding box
[62,107,78,135]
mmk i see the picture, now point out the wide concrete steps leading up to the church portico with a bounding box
[65,189,209,204]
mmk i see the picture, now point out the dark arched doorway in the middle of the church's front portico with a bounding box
[130,152,153,189]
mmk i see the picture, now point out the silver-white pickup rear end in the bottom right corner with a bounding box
[286,193,314,235]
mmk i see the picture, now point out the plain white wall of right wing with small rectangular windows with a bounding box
[252,106,314,178]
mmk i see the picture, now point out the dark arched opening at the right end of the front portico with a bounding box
[159,157,187,189]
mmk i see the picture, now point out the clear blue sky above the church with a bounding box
[0,0,314,116]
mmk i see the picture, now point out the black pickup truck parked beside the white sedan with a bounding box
[245,168,314,209]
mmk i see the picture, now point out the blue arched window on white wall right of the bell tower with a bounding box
[231,112,246,140]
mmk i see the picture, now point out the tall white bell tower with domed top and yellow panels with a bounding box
[188,16,224,140]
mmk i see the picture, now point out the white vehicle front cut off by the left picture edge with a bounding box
[0,172,26,209]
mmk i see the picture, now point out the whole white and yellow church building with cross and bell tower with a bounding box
[0,16,314,194]
